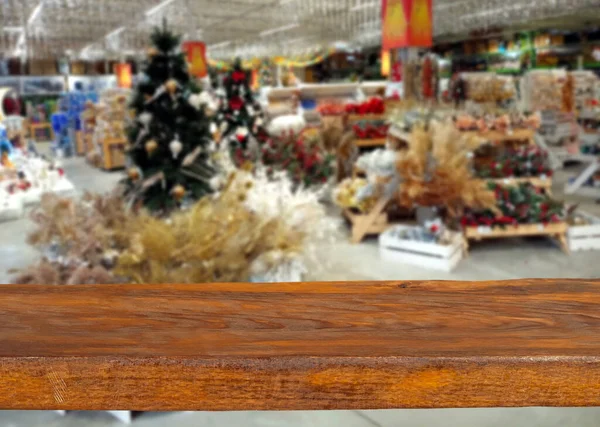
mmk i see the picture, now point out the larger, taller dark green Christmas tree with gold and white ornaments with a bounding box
[125,25,214,213]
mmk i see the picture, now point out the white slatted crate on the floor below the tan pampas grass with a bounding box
[379,225,464,272]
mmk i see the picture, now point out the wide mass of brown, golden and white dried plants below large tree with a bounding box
[14,169,337,284]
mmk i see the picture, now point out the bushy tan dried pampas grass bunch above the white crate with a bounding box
[397,121,496,218]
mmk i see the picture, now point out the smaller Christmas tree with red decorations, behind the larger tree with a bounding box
[216,59,268,152]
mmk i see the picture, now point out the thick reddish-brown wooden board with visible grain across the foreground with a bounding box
[0,280,600,410]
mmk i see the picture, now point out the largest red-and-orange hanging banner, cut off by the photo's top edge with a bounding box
[381,0,433,50]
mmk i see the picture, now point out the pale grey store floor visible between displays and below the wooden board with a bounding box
[0,158,600,427]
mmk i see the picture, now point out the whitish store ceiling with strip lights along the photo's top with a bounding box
[0,0,600,59]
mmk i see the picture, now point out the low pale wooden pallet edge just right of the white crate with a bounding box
[464,222,570,254]
